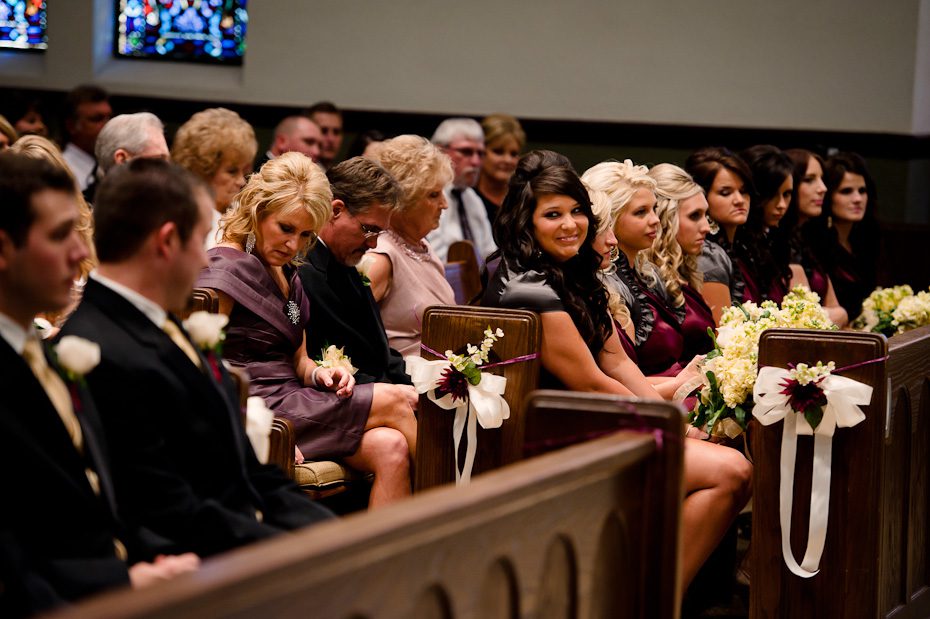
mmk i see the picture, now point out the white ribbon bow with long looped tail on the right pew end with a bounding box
[752,367,872,578]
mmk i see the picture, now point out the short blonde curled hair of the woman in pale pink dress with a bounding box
[371,135,452,214]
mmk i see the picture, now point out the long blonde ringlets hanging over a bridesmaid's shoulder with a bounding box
[644,163,704,306]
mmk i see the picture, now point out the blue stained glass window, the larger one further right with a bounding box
[114,0,249,64]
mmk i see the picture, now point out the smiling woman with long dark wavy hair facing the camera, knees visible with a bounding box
[484,151,752,586]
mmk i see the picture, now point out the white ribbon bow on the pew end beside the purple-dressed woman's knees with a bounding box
[404,356,510,486]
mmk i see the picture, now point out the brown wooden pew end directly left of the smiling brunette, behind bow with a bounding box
[414,305,540,491]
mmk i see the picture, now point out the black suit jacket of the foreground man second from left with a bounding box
[62,279,330,556]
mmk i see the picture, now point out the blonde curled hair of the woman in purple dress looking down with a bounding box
[220,152,333,264]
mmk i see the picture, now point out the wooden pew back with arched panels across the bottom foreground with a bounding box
[49,432,681,619]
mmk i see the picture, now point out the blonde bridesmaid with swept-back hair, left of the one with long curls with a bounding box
[582,160,685,376]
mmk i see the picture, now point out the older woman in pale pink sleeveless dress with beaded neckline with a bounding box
[368,135,455,356]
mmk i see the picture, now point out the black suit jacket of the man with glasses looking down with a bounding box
[299,243,410,385]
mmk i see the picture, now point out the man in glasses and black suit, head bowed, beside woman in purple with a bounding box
[300,157,416,390]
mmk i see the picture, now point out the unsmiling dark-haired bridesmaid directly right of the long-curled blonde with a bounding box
[685,147,762,324]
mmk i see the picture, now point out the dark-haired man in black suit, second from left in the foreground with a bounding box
[63,159,330,556]
